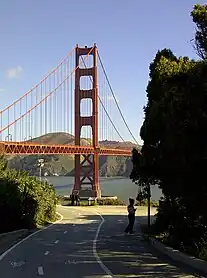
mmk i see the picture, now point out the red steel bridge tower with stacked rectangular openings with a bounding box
[73,44,101,197]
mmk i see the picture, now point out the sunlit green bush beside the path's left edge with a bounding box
[0,158,57,232]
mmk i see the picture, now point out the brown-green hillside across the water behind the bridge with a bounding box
[8,132,141,176]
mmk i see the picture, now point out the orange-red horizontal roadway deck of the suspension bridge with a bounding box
[0,141,132,156]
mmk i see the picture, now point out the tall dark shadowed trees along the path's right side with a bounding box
[131,5,207,256]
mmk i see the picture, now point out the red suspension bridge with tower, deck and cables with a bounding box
[0,44,137,197]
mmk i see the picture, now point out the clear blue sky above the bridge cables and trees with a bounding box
[0,0,205,142]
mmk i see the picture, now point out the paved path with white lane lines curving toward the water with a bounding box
[0,207,200,278]
